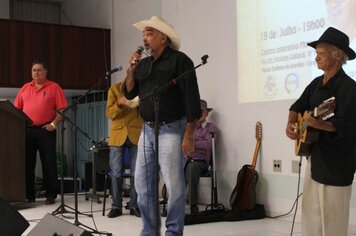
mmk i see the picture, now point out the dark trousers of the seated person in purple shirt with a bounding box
[184,159,209,207]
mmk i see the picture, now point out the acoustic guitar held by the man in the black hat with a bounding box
[295,97,336,156]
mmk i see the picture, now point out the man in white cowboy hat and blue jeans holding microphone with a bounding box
[123,16,201,235]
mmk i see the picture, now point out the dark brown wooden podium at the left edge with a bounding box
[0,99,32,202]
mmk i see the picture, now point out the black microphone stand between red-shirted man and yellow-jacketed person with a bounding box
[56,67,118,236]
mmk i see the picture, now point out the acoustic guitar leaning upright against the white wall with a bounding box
[230,122,262,211]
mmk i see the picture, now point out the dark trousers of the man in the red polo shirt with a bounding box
[26,127,59,199]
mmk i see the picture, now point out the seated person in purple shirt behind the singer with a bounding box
[184,100,218,214]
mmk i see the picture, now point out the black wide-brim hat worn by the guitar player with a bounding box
[307,27,356,60]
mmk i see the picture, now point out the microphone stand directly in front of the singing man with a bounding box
[140,55,209,236]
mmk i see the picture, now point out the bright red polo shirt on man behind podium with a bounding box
[14,80,67,126]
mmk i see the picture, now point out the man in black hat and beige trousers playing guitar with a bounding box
[286,27,356,236]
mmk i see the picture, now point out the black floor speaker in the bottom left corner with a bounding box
[0,197,30,235]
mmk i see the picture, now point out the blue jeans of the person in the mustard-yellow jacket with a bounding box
[109,138,137,209]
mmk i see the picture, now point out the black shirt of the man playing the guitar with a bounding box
[290,69,356,186]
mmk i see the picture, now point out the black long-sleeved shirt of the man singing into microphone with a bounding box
[123,47,201,122]
